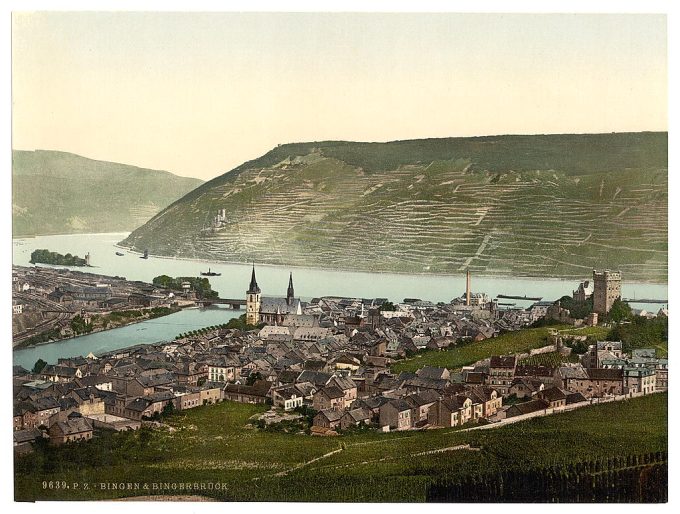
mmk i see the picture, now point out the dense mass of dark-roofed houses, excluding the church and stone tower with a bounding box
[14,288,668,451]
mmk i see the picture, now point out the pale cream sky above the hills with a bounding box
[12,12,667,180]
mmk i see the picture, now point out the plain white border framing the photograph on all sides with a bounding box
[0,0,680,513]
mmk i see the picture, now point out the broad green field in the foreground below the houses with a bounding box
[15,394,668,501]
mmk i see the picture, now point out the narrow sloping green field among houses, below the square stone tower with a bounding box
[391,326,564,373]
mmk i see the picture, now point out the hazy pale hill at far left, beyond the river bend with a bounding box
[12,150,203,236]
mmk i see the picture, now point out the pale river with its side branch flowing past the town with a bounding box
[12,233,668,369]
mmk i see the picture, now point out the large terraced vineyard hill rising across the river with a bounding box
[123,132,668,281]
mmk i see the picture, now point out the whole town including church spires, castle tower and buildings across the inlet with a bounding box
[13,266,668,453]
